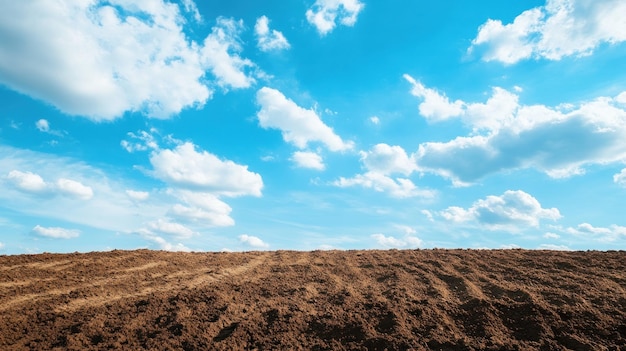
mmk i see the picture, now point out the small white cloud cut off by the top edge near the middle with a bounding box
[306,0,365,35]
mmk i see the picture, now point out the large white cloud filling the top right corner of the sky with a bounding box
[468,0,626,64]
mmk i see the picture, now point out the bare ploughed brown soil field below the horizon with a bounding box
[0,250,626,350]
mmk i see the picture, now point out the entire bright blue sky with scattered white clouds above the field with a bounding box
[0,0,626,254]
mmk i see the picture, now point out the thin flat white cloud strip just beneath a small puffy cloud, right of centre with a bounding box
[333,172,435,198]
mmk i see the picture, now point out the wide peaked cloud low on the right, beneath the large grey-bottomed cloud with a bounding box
[439,190,561,231]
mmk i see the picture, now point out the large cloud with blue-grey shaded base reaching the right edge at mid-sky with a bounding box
[413,80,626,186]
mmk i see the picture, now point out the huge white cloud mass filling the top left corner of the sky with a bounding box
[0,0,254,120]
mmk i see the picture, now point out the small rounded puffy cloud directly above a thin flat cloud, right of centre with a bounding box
[360,144,417,175]
